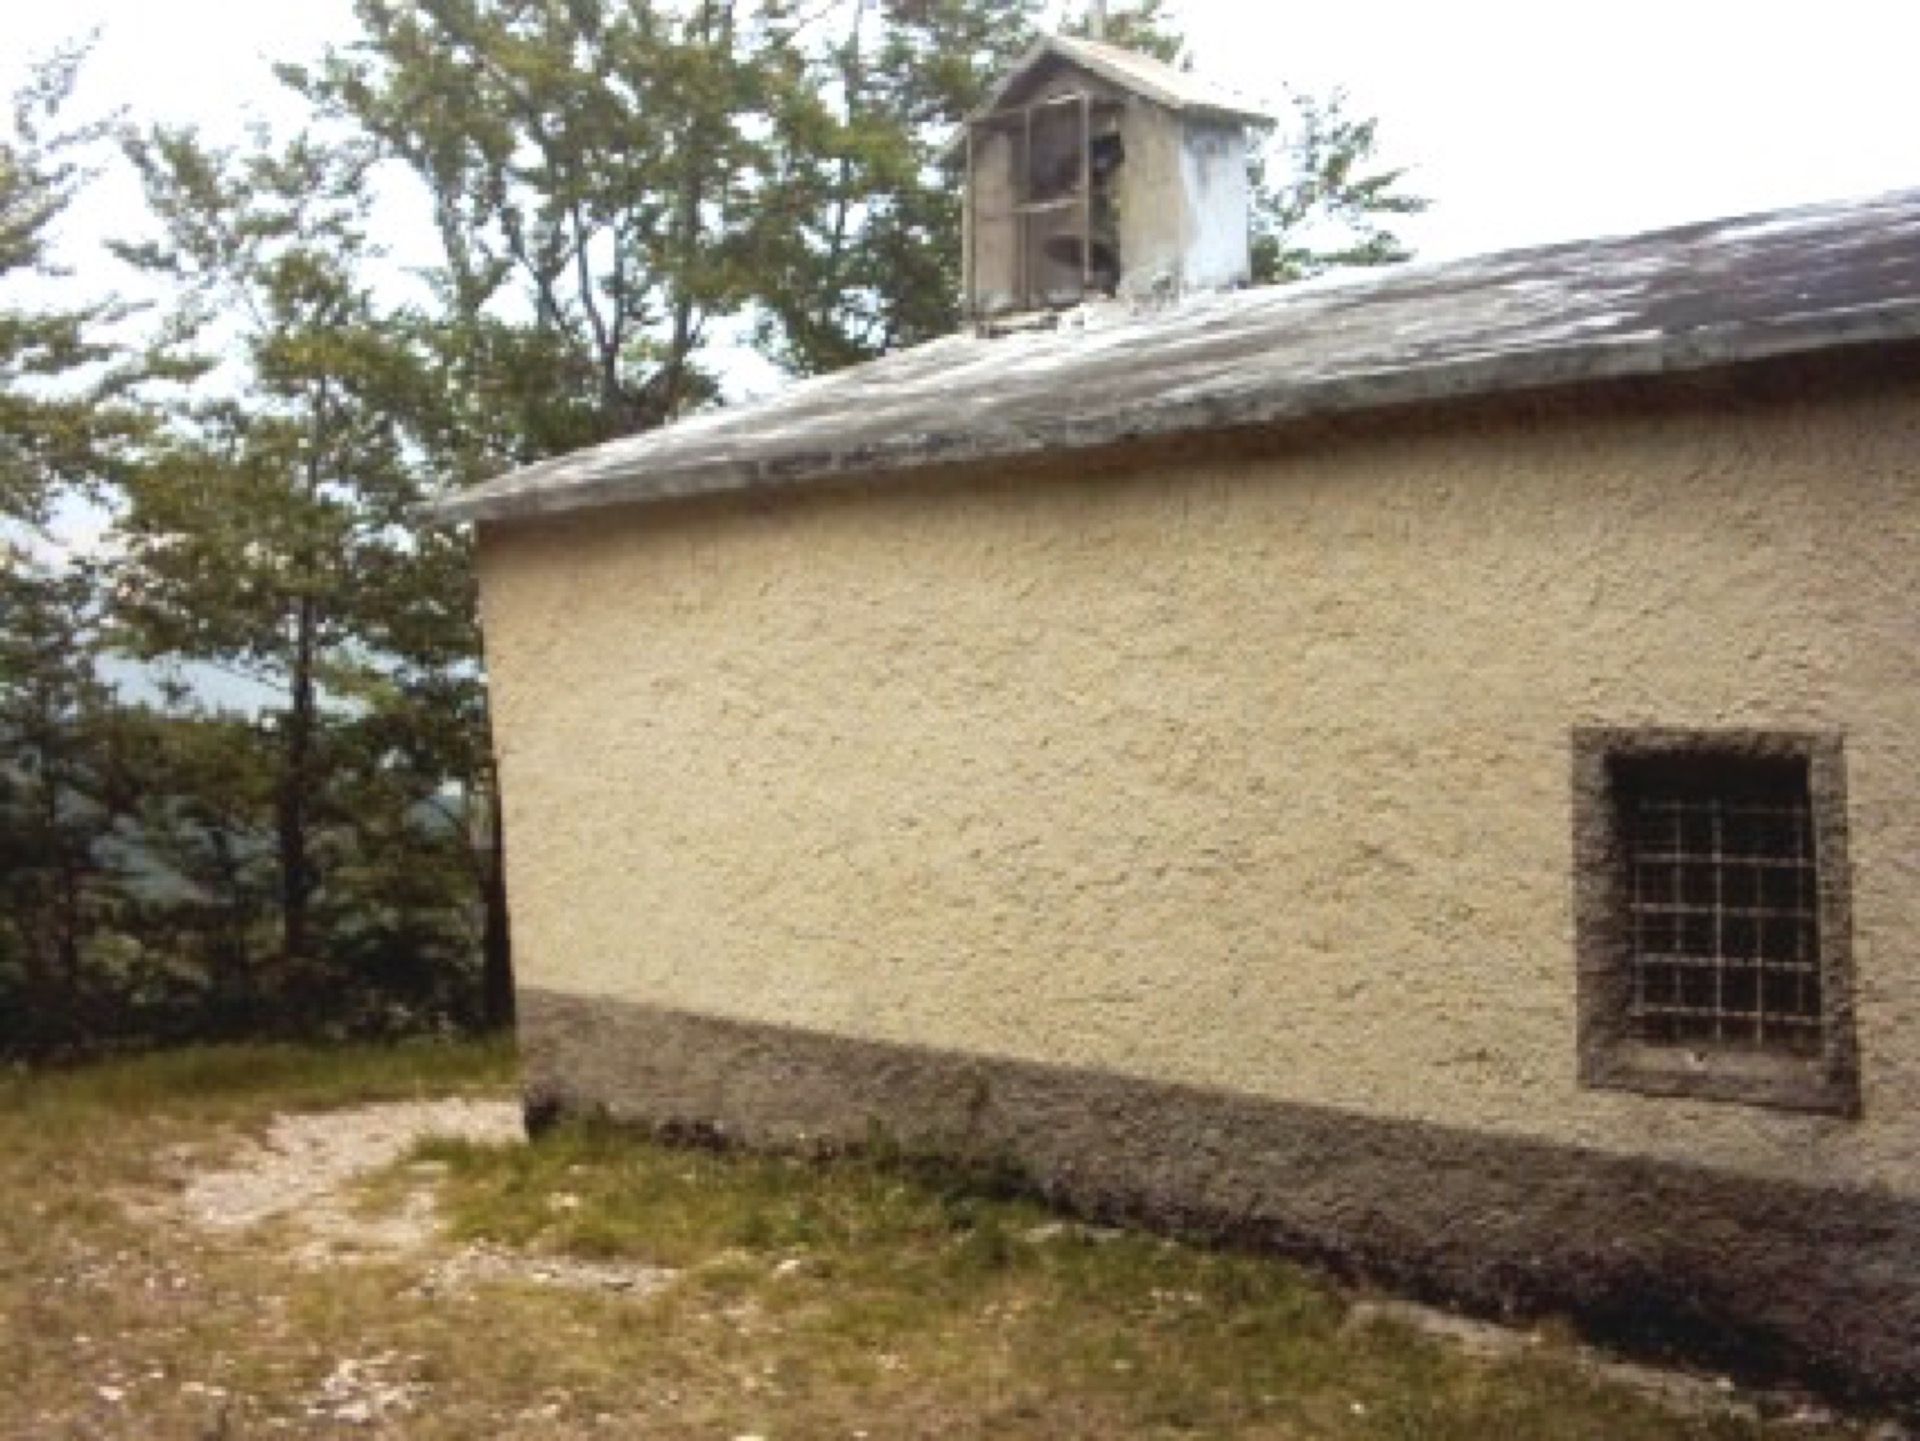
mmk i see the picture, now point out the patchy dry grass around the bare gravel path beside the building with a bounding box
[0,1046,1873,1441]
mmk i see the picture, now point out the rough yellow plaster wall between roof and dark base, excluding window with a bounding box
[482,368,1920,1195]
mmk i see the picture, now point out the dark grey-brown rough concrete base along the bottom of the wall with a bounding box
[520,990,1920,1405]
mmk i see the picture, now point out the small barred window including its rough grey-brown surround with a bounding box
[1574,731,1859,1113]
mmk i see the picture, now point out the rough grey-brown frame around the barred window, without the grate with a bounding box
[1572,727,1860,1117]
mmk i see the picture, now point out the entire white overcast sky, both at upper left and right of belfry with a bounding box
[0,0,1920,278]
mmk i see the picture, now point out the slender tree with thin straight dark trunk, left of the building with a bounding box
[113,130,441,1013]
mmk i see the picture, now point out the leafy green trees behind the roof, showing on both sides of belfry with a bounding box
[303,0,1423,397]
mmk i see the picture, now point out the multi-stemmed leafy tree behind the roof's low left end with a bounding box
[282,0,780,462]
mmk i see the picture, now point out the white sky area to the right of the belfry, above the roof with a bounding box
[1188,0,1920,259]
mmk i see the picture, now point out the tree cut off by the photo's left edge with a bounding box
[0,46,153,1044]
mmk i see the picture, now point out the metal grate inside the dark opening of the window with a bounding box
[1620,758,1822,1051]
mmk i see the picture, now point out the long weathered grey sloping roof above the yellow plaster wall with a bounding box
[438,190,1920,520]
